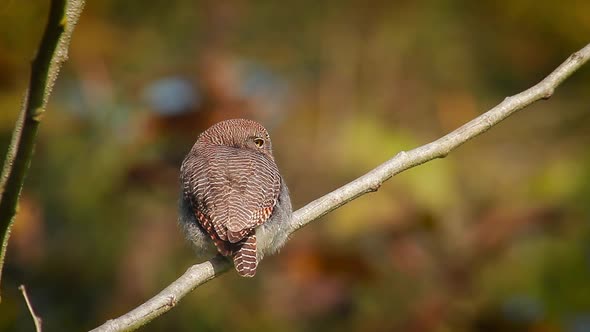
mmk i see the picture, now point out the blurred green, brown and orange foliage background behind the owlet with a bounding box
[0,0,590,332]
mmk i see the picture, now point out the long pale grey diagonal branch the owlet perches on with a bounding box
[92,44,590,331]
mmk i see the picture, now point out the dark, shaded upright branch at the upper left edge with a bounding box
[0,0,84,298]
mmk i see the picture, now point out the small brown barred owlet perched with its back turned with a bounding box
[179,119,292,277]
